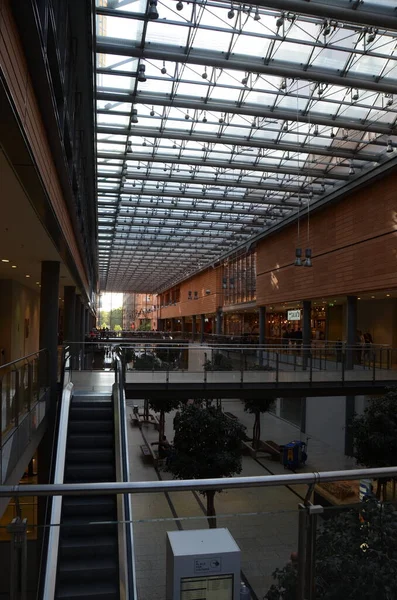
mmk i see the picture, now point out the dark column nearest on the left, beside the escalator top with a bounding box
[40,261,60,403]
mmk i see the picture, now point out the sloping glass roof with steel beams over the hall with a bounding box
[96,0,397,292]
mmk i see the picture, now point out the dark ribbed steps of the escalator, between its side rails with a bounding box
[55,394,120,600]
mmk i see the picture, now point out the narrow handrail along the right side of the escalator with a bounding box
[114,353,137,600]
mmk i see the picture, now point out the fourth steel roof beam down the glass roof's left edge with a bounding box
[97,152,346,181]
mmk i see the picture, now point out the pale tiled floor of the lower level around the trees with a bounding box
[128,400,354,600]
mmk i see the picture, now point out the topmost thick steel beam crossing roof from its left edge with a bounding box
[96,36,397,95]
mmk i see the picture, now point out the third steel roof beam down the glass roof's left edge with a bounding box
[97,123,379,162]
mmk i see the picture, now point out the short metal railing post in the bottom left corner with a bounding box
[7,517,27,600]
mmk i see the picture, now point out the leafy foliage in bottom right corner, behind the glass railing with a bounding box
[265,499,397,600]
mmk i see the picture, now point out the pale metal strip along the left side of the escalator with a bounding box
[43,382,73,600]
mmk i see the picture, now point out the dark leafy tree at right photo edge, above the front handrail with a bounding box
[351,388,397,500]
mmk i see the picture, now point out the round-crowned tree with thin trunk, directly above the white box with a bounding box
[168,405,244,528]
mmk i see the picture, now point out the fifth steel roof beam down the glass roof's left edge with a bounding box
[98,170,320,194]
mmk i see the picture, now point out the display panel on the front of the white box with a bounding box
[180,574,233,600]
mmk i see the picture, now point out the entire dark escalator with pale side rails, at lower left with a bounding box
[38,356,136,600]
